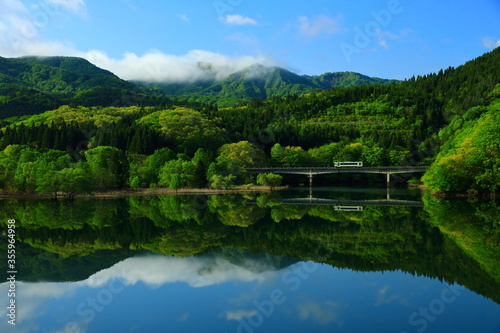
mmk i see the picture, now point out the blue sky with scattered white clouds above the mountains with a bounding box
[0,0,500,81]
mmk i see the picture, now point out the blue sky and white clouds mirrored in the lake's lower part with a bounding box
[0,254,500,332]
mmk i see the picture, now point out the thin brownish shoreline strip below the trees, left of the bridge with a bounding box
[0,185,288,199]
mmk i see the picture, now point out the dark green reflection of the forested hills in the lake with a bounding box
[0,194,500,303]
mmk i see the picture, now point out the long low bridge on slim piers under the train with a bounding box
[245,166,427,188]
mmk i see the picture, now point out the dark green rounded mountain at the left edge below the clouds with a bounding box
[0,57,156,118]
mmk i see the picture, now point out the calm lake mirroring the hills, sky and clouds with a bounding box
[0,188,500,333]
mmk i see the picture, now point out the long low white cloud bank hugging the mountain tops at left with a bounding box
[0,34,275,83]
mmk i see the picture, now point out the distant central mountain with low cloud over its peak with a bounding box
[136,64,398,106]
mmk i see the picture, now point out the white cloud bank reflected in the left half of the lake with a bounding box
[0,255,278,333]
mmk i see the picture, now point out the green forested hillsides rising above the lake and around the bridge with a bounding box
[0,48,500,199]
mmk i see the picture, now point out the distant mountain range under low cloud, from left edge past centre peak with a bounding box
[0,57,397,118]
